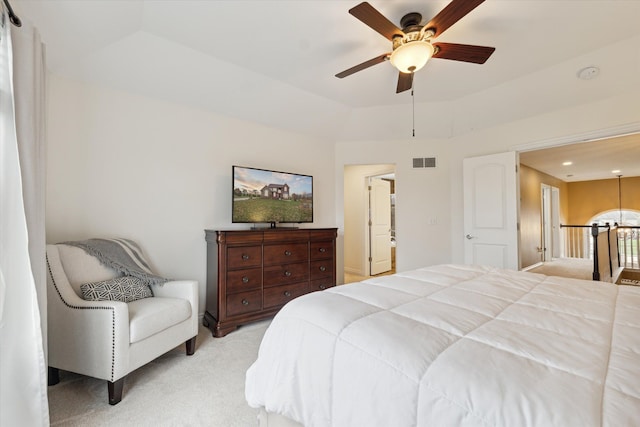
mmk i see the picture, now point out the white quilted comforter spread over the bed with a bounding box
[245,265,640,427]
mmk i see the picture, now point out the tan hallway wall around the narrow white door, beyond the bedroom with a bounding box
[520,164,568,268]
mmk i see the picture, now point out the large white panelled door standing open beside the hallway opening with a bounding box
[463,151,519,270]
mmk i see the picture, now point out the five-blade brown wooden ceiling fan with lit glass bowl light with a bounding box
[336,0,496,93]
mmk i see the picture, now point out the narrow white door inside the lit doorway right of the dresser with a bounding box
[369,178,391,276]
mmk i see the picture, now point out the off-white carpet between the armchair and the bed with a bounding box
[49,321,270,427]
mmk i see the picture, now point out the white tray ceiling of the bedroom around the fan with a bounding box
[11,0,640,177]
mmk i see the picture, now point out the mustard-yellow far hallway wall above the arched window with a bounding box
[567,177,640,224]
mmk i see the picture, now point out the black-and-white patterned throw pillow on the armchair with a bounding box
[80,276,153,302]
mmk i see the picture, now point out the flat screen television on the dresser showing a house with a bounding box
[231,166,313,228]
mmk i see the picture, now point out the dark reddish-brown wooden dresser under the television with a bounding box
[203,228,337,337]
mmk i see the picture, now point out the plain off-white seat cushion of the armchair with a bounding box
[128,297,191,344]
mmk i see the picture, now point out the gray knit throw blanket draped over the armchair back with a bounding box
[63,239,169,285]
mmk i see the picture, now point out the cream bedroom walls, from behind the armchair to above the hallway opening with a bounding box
[46,75,640,288]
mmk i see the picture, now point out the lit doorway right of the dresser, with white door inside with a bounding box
[343,164,396,283]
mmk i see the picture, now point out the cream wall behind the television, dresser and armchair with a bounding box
[46,75,342,313]
